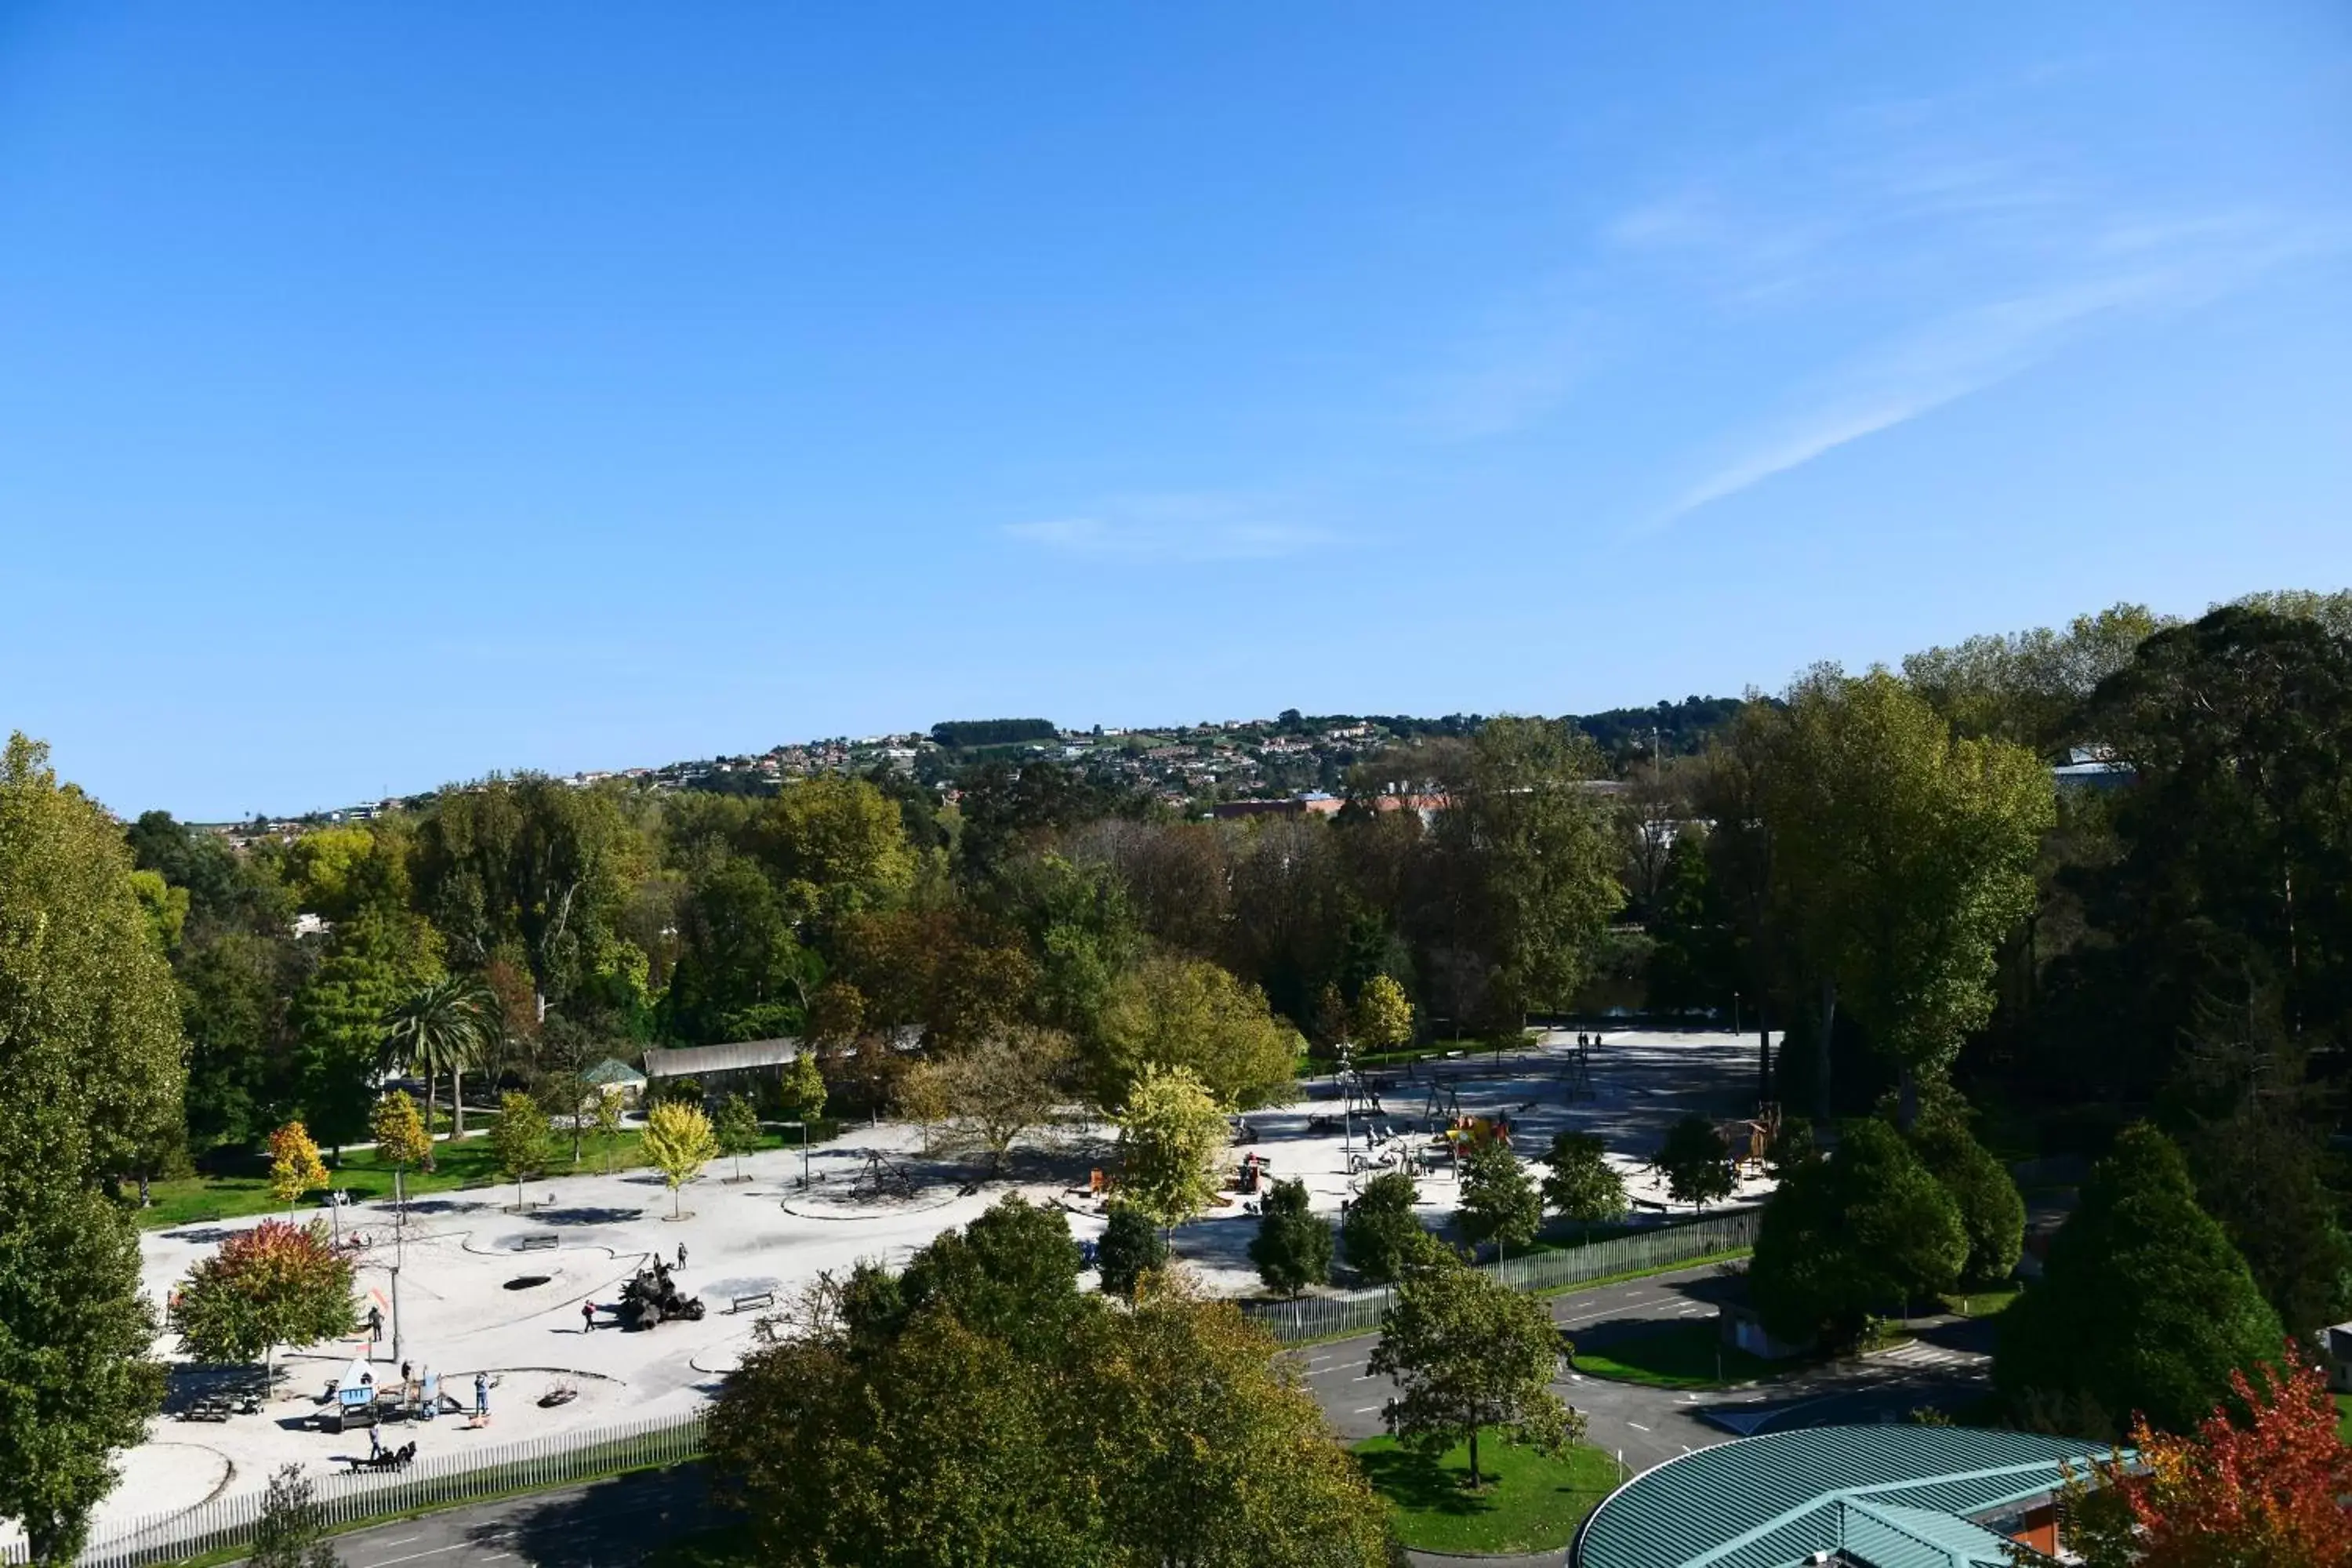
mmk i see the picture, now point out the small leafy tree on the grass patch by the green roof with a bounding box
[1364,1253,1585,1488]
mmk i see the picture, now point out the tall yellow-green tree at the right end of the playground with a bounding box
[1764,670,2058,1128]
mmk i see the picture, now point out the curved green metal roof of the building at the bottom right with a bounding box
[1569,1425,2107,1568]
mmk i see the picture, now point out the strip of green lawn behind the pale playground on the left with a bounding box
[139,1112,837,1229]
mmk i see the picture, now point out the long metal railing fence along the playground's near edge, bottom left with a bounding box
[0,1413,708,1568]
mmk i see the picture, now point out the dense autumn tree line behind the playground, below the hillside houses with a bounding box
[125,720,1621,1156]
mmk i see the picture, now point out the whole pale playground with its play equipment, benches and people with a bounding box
[55,1032,1764,1542]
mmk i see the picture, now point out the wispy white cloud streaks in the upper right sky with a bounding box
[1595,78,2352,527]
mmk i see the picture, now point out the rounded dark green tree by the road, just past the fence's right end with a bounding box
[1748,1121,1969,1345]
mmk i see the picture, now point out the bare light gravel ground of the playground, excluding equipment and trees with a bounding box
[36,1032,1755,1540]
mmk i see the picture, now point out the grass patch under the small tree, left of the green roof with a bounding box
[1355,1432,1618,1556]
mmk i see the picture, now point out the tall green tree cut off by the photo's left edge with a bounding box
[0,736,183,1563]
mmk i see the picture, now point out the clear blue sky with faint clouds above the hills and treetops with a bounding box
[0,0,2352,818]
